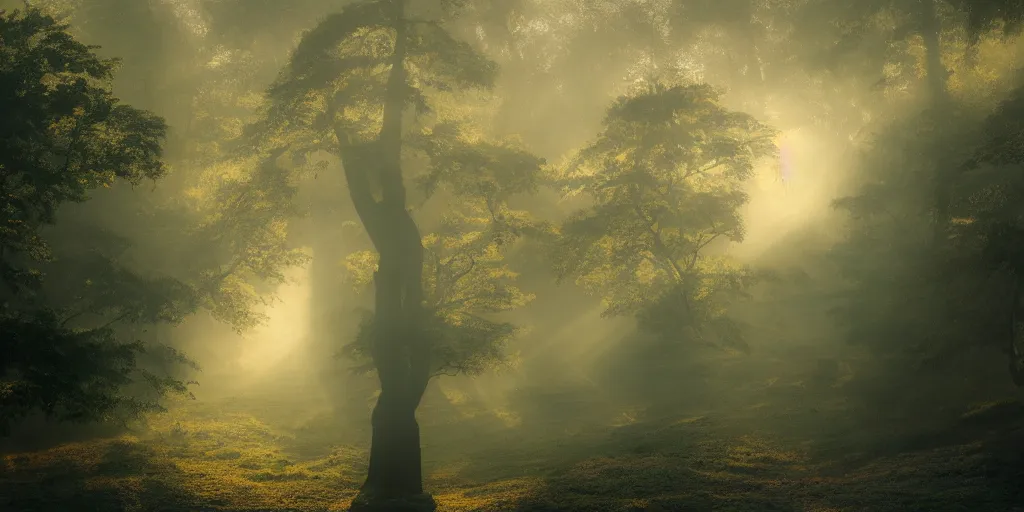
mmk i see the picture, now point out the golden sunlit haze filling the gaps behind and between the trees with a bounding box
[6,0,1024,507]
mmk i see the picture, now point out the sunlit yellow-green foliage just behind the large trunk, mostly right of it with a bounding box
[346,124,547,375]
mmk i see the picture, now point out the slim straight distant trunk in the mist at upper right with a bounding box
[920,0,951,246]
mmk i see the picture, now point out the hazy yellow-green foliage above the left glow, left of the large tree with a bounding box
[148,37,308,332]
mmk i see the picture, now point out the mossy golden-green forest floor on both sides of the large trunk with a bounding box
[0,352,1024,512]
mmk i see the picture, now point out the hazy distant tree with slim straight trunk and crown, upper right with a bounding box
[798,0,1024,242]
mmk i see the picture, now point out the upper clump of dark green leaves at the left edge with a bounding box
[0,10,166,286]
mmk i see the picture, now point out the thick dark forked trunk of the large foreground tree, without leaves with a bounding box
[339,0,433,512]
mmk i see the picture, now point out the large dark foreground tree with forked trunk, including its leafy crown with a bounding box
[250,0,539,510]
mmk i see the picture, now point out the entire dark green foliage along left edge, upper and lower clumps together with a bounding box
[0,9,196,429]
